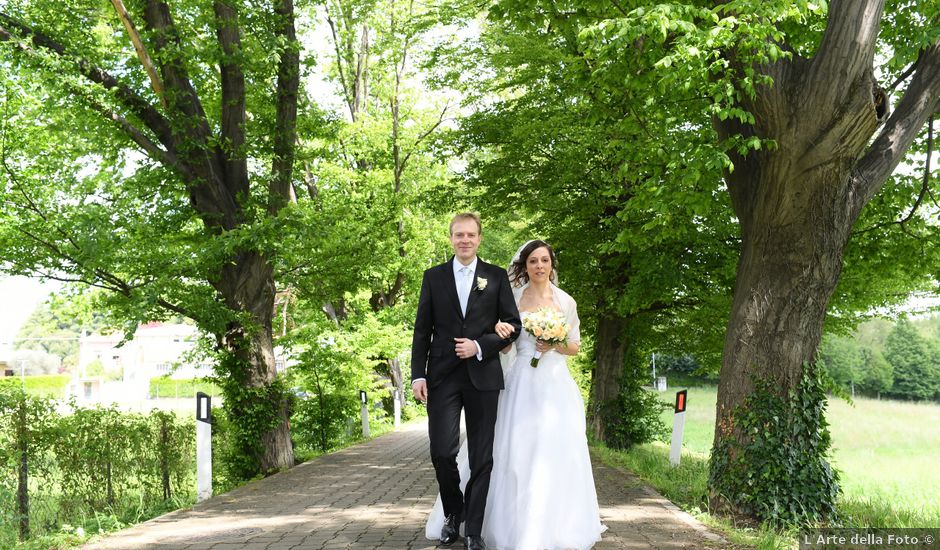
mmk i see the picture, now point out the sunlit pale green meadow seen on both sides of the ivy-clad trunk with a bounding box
[662,386,940,527]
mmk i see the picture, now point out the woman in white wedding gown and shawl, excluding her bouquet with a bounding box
[425,240,606,550]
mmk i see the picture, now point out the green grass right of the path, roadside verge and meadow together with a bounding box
[594,385,940,549]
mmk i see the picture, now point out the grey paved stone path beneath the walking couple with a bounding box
[85,423,730,550]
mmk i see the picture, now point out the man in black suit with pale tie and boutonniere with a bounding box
[411,213,522,550]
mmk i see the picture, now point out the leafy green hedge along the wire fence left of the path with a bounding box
[0,388,195,548]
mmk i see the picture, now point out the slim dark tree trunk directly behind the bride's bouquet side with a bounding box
[589,314,626,441]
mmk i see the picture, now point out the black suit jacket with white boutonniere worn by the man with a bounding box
[411,257,522,391]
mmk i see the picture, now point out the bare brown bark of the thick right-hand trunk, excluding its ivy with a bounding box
[709,129,874,516]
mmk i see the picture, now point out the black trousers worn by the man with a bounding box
[428,364,499,535]
